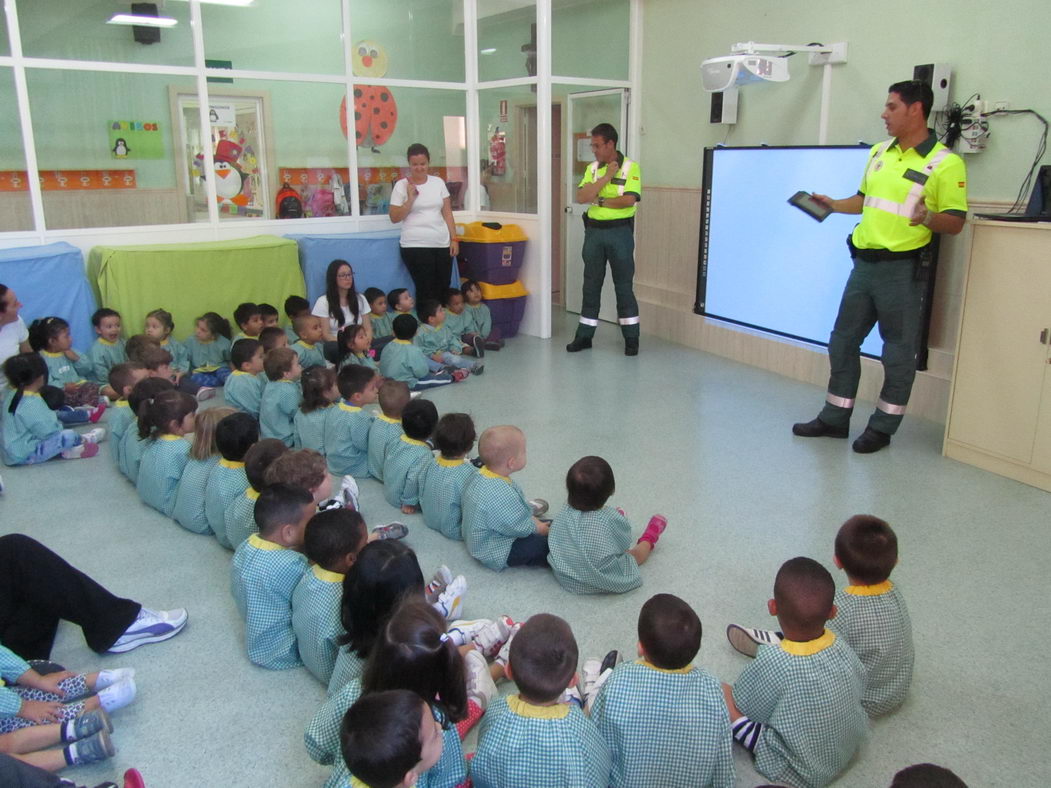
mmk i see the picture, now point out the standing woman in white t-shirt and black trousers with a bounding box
[390,142,459,304]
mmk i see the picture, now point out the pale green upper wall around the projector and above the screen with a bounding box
[641,0,1051,201]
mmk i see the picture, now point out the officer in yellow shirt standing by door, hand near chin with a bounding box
[565,123,642,356]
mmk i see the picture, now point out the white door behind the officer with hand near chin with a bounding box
[562,87,627,323]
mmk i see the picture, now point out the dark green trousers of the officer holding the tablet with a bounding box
[819,258,927,435]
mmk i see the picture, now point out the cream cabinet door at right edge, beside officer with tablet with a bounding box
[949,225,1051,464]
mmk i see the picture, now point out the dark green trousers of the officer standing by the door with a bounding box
[577,224,639,339]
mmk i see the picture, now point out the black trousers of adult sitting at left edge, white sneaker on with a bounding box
[0,534,142,660]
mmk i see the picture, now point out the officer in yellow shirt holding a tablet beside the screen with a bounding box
[792,81,967,454]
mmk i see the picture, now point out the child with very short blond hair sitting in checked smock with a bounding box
[460,426,549,572]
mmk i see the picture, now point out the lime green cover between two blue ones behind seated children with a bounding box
[87,235,306,339]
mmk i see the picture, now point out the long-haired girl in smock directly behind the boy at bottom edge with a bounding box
[304,597,472,788]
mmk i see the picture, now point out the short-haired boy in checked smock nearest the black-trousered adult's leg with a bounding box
[230,484,314,670]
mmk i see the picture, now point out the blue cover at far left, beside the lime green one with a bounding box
[0,243,96,352]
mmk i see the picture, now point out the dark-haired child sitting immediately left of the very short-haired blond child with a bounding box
[419,413,477,540]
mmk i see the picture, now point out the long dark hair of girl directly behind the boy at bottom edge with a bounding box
[362,596,468,722]
